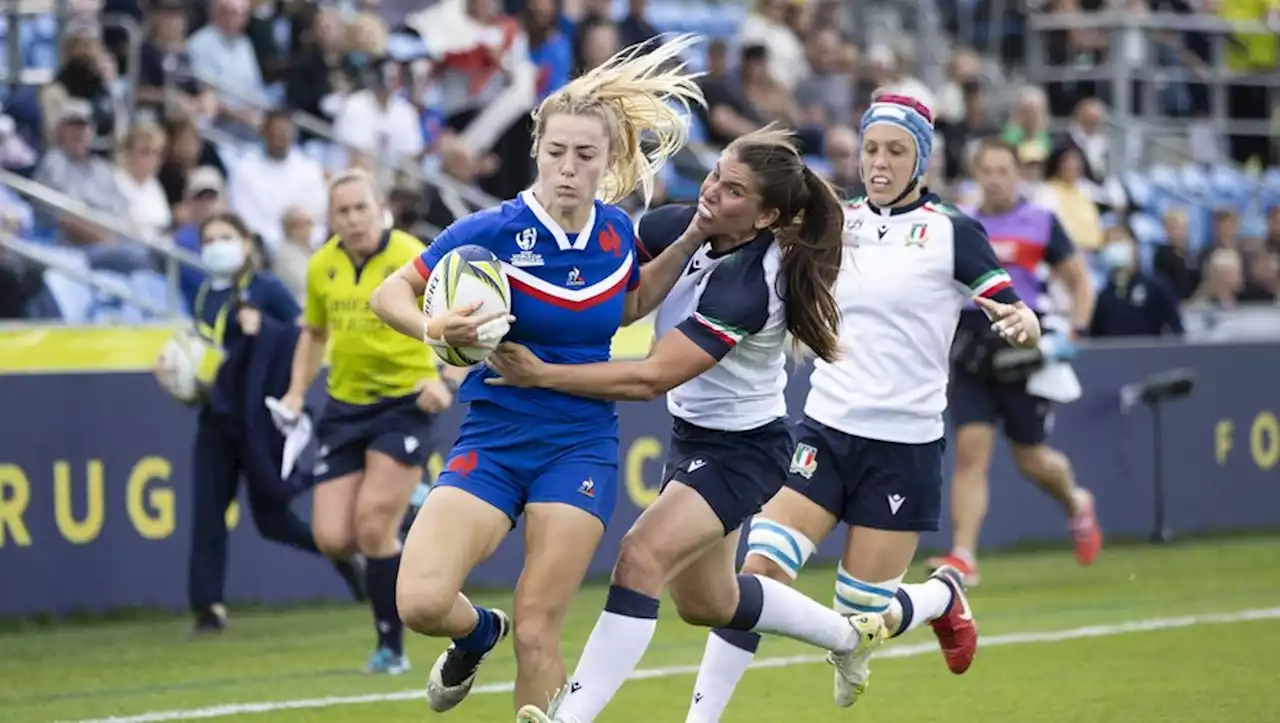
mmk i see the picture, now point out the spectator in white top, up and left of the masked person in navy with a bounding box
[115,123,173,241]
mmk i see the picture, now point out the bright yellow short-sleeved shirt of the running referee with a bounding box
[303,230,438,404]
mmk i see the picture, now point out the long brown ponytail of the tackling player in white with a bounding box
[777,166,845,362]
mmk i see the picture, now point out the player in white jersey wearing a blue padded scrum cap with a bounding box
[687,95,1039,723]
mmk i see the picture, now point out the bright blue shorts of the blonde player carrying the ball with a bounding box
[435,402,618,526]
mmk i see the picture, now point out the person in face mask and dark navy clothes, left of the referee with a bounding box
[156,214,364,633]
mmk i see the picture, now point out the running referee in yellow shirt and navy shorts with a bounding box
[282,170,453,674]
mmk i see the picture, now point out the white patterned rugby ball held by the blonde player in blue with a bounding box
[422,244,511,367]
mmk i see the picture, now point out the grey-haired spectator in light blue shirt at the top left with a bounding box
[187,0,266,139]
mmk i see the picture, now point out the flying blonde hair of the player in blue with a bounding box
[532,33,707,206]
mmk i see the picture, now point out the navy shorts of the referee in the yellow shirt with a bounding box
[315,394,433,482]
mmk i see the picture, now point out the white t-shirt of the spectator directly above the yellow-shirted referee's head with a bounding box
[334,90,424,161]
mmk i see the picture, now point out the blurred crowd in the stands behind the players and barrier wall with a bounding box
[0,0,1280,335]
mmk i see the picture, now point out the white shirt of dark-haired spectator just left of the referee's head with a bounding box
[227,148,329,255]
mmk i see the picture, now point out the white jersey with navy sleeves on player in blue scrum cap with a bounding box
[804,193,1018,444]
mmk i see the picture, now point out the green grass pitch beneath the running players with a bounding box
[0,537,1280,723]
